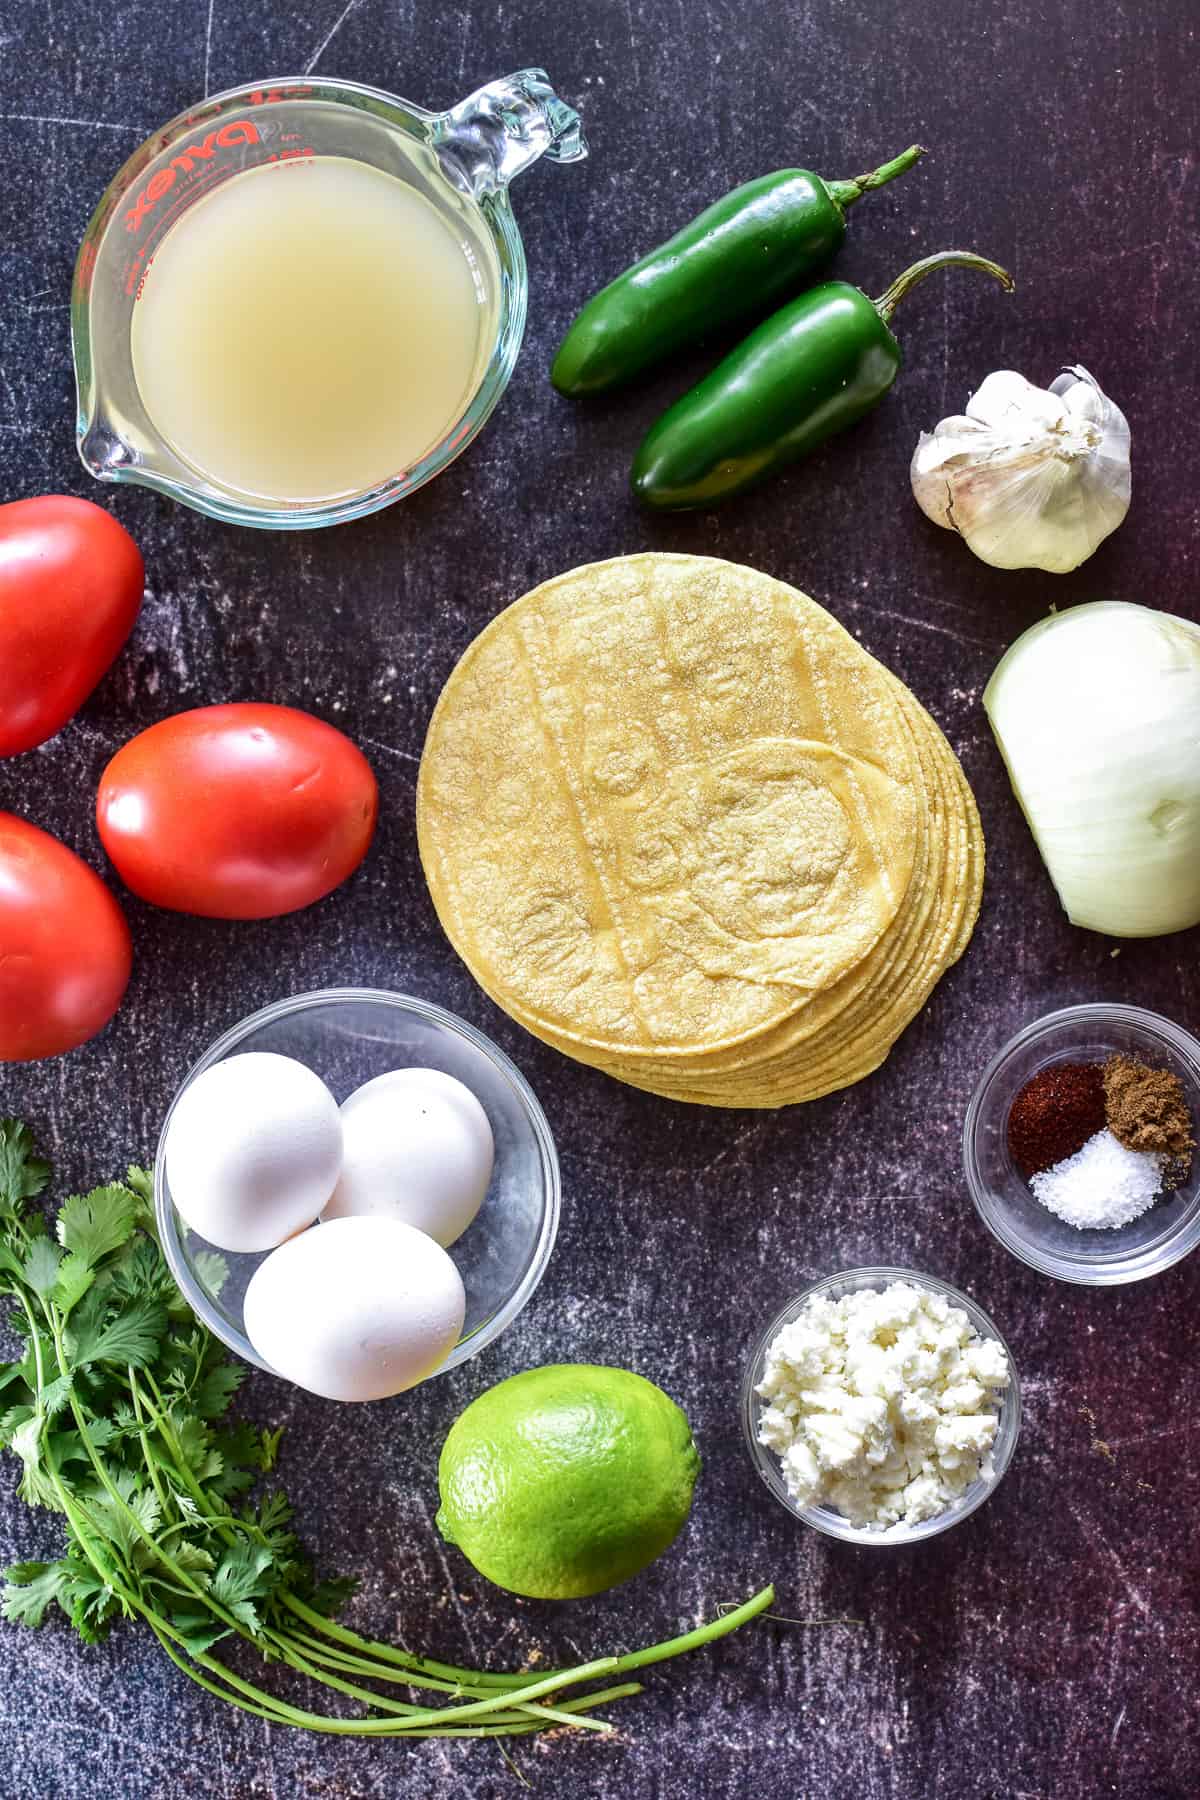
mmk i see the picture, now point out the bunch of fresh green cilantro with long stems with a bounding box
[0,1120,774,1737]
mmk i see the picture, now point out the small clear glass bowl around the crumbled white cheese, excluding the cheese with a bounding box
[741,1269,1020,1546]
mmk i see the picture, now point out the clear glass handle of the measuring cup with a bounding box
[435,68,588,200]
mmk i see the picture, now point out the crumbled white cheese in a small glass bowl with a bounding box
[757,1282,1009,1530]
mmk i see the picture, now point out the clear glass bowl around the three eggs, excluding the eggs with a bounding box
[155,988,561,1375]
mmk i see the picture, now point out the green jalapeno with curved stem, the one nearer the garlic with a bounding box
[631,250,1013,511]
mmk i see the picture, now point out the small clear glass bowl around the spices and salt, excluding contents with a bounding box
[963,1004,1200,1287]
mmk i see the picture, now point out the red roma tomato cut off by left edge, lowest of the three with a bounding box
[0,812,133,1062]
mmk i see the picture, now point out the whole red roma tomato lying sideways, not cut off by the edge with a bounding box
[95,704,380,918]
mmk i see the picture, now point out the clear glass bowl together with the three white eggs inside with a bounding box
[155,988,560,1400]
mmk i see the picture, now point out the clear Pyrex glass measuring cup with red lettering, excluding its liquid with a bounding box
[70,68,587,531]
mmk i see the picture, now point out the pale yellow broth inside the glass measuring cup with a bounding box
[130,155,498,506]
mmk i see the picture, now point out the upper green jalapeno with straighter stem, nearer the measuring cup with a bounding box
[551,144,925,394]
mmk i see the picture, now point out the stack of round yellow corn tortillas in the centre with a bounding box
[417,554,984,1107]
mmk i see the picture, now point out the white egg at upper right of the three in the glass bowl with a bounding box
[324,1069,495,1247]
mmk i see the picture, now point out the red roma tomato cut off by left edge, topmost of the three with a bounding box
[0,493,144,756]
